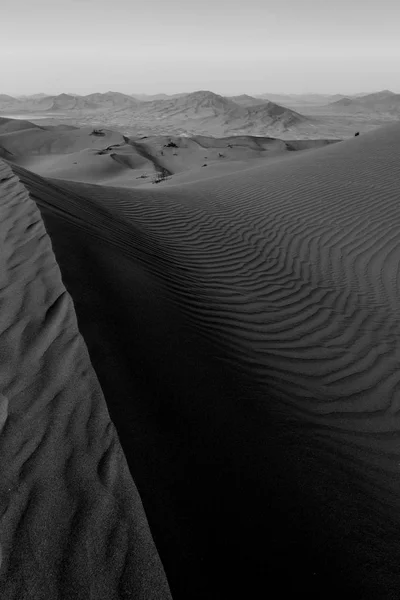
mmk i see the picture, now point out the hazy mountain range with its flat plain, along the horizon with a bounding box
[0,90,400,138]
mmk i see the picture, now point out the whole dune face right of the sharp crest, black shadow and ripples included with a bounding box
[10,126,400,600]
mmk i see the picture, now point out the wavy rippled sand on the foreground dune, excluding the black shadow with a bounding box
[12,126,400,598]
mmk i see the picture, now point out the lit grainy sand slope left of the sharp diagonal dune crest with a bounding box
[0,161,171,600]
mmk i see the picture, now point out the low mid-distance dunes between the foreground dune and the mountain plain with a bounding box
[0,119,339,187]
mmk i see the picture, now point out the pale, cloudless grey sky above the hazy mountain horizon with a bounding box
[0,0,400,95]
